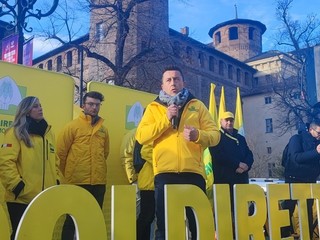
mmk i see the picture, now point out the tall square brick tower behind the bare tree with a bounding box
[89,0,169,85]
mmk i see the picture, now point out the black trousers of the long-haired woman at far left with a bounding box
[7,202,28,240]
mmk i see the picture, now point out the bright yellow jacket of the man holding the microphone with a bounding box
[136,99,220,178]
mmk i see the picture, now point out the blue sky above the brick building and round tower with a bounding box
[34,0,320,57]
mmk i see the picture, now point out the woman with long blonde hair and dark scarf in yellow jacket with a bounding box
[0,96,60,240]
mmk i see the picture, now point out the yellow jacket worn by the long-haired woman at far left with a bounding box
[0,126,59,204]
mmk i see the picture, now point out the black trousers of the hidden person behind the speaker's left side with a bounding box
[137,190,155,240]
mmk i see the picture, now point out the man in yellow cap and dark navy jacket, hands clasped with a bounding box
[209,112,253,213]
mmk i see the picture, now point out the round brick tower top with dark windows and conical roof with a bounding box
[208,18,267,61]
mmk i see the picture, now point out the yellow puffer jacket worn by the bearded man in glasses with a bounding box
[57,113,109,185]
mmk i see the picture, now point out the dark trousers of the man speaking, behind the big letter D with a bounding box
[154,173,206,240]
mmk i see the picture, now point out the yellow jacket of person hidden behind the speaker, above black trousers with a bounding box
[138,144,154,190]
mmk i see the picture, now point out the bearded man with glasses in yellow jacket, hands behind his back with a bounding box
[57,91,109,240]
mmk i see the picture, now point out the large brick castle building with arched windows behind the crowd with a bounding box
[34,0,265,111]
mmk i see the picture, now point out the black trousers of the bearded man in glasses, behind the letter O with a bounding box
[61,185,106,240]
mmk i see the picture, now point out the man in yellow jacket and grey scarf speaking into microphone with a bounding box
[136,66,220,240]
